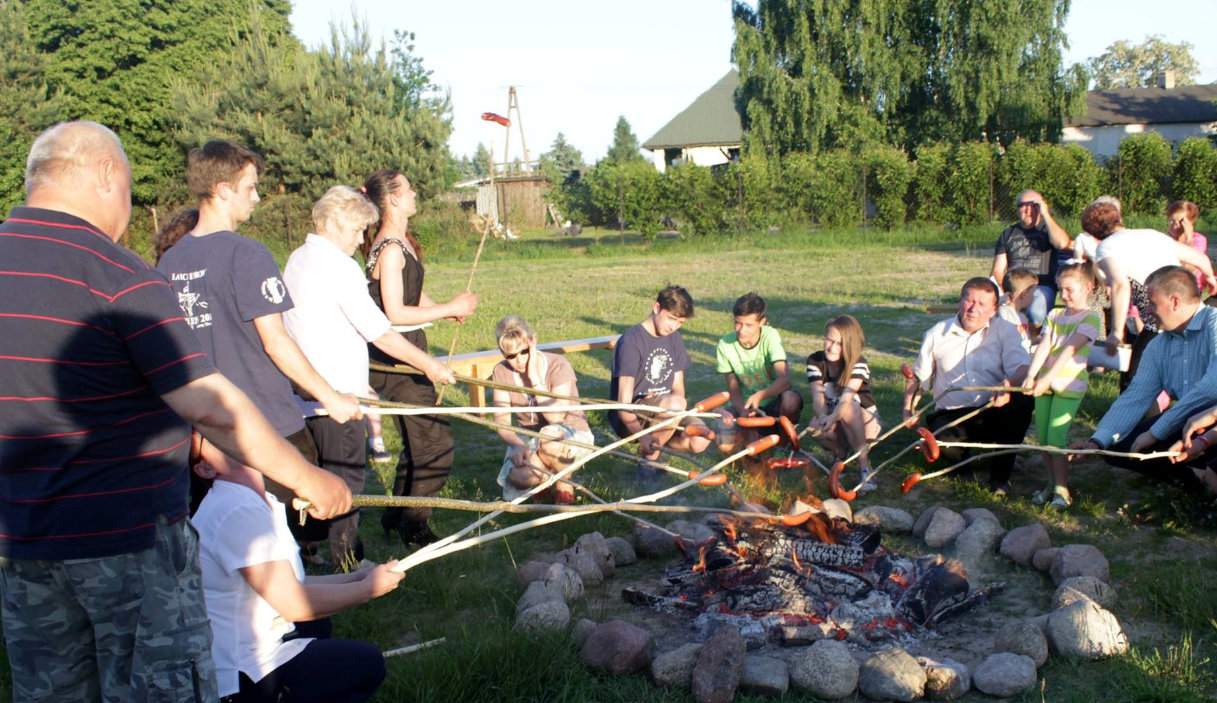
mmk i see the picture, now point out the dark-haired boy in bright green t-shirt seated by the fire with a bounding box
[716,293,803,452]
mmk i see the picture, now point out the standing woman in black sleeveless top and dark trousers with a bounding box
[363,169,477,546]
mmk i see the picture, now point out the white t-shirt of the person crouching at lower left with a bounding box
[190,480,313,696]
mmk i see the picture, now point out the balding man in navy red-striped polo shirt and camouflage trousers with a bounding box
[0,122,350,701]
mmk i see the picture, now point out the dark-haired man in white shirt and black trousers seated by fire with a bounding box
[903,277,1034,495]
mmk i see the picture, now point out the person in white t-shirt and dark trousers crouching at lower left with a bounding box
[191,442,404,703]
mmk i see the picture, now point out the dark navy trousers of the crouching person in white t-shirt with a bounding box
[224,619,385,703]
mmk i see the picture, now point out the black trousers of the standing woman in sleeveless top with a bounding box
[369,371,454,529]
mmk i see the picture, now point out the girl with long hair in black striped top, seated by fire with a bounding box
[807,315,880,490]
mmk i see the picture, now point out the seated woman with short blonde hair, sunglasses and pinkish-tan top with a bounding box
[492,315,595,504]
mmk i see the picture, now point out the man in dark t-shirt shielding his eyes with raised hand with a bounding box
[989,190,1070,330]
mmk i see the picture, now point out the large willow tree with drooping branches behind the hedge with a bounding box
[733,0,1086,156]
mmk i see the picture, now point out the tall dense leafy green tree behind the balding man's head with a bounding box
[22,0,291,203]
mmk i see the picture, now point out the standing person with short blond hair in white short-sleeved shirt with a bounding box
[284,186,453,566]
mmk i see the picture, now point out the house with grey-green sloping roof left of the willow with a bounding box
[643,68,744,173]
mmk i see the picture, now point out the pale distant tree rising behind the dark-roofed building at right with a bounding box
[1087,34,1200,90]
